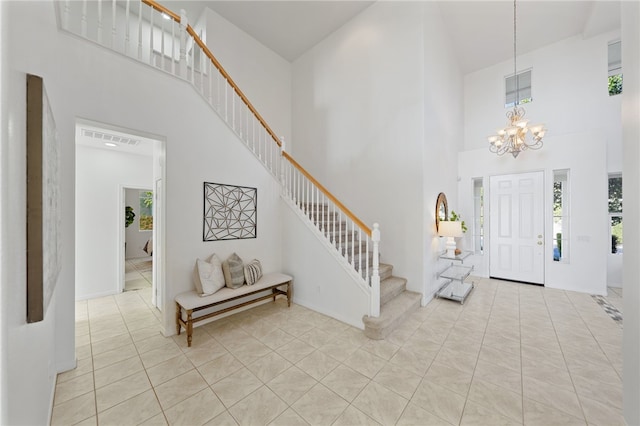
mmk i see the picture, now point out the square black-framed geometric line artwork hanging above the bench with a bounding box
[202,182,258,241]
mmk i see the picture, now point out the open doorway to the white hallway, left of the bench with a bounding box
[75,119,165,309]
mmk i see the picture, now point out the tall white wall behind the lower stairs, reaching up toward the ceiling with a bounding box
[293,2,462,301]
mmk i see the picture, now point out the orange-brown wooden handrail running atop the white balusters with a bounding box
[141,0,371,237]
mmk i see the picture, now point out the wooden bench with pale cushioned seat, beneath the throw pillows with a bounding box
[175,273,293,347]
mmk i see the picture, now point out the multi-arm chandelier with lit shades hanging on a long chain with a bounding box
[488,0,547,158]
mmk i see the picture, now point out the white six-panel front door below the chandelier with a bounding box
[489,172,544,284]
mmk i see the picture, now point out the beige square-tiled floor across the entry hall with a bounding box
[52,279,624,426]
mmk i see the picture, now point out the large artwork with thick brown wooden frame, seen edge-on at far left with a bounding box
[26,74,62,323]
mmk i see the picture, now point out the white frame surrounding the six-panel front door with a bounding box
[490,168,548,286]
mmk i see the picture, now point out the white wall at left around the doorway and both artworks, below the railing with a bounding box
[2,2,282,424]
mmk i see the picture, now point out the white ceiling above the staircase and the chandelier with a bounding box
[161,0,620,74]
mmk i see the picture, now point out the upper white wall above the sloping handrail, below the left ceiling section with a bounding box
[202,8,291,147]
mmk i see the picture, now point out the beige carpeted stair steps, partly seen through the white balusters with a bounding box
[302,204,422,340]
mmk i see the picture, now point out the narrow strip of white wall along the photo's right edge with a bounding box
[621,2,640,425]
